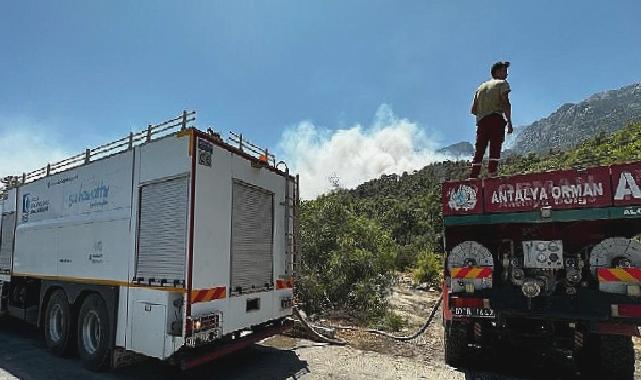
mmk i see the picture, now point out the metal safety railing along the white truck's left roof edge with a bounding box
[2,111,196,188]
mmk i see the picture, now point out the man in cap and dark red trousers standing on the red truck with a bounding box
[470,62,513,178]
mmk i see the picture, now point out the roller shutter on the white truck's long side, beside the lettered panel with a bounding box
[136,177,189,286]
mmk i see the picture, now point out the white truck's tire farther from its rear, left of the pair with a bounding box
[44,290,74,356]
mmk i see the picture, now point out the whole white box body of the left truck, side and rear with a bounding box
[0,130,293,359]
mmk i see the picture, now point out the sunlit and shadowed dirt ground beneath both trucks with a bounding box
[0,320,641,380]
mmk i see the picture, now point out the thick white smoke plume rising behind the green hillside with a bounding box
[279,104,450,199]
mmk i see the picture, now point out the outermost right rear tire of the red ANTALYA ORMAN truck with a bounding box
[600,335,634,380]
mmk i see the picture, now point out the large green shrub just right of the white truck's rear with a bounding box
[296,192,397,322]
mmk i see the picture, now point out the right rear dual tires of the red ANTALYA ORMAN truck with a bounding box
[579,334,634,380]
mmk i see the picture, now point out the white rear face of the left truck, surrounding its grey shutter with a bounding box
[192,137,292,334]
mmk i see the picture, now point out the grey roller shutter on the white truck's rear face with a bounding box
[231,180,274,295]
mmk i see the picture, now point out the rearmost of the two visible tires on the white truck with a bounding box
[78,293,112,371]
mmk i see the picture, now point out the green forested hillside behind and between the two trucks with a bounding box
[298,122,641,322]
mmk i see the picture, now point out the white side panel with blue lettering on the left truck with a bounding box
[13,152,133,281]
